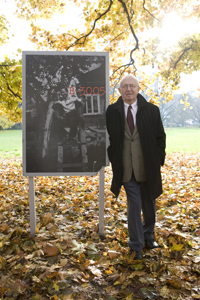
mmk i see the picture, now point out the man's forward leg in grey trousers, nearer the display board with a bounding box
[124,177,144,251]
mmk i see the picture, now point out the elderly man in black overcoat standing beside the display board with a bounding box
[106,75,166,259]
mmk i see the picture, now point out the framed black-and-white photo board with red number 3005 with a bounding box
[22,51,109,176]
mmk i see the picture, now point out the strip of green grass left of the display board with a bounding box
[0,130,22,159]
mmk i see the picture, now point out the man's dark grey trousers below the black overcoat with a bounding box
[123,175,156,251]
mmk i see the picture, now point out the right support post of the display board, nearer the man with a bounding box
[99,167,105,238]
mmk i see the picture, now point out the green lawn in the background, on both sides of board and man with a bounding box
[0,128,200,159]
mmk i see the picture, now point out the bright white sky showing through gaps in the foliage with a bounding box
[0,0,200,92]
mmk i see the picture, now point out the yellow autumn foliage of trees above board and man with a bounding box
[0,0,200,121]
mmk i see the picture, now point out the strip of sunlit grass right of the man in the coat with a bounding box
[165,128,200,153]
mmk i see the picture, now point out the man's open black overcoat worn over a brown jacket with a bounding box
[106,94,166,199]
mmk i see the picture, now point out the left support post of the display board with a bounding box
[28,177,36,236]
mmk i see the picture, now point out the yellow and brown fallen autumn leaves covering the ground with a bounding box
[0,153,200,300]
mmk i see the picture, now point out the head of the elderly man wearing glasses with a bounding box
[118,77,140,104]
